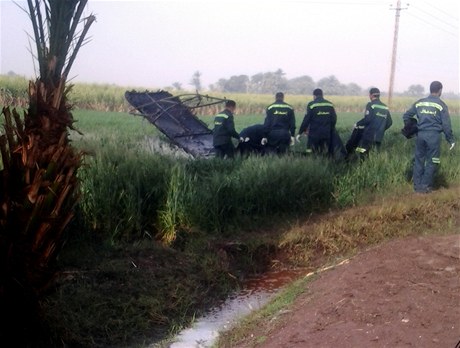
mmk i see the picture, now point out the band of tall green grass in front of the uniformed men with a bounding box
[73,126,460,244]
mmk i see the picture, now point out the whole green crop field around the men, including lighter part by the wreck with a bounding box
[72,110,460,240]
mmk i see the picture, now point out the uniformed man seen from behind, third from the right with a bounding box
[299,88,337,156]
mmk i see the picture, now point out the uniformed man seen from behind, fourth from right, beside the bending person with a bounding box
[262,92,295,154]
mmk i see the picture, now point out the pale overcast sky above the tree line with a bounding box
[0,0,460,93]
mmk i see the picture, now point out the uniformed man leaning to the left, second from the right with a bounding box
[355,88,393,156]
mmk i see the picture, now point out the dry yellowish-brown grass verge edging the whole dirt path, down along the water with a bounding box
[215,186,460,348]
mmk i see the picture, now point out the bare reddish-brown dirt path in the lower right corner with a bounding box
[240,234,460,348]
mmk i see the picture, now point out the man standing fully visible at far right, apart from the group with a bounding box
[403,81,455,193]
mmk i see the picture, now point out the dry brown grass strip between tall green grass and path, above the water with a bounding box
[280,187,460,263]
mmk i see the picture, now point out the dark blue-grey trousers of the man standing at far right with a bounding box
[412,131,441,192]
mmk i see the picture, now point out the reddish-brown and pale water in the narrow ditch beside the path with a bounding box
[164,270,308,348]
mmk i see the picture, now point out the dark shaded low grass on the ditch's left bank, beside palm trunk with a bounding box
[42,241,239,347]
